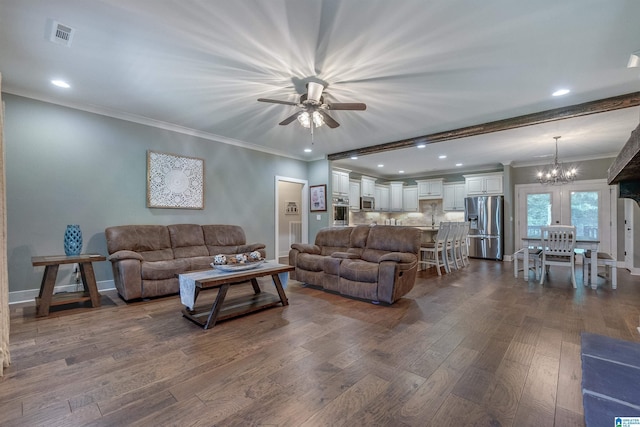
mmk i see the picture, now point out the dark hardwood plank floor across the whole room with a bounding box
[0,260,640,427]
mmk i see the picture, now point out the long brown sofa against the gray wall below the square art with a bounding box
[105,224,266,301]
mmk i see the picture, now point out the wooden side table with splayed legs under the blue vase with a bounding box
[31,254,107,317]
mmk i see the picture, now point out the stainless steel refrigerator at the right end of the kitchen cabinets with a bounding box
[464,196,504,260]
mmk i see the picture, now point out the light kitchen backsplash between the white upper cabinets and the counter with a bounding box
[349,200,464,227]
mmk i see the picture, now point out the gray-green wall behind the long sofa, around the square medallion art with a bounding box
[3,94,308,292]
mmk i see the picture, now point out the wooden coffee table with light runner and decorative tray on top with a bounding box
[178,262,295,329]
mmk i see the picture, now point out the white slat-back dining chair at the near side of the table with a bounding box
[540,225,577,288]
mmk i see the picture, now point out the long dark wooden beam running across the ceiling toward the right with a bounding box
[327,92,640,160]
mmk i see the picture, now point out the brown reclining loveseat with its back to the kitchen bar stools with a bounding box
[289,225,422,304]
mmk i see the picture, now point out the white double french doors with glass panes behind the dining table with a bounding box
[514,180,617,257]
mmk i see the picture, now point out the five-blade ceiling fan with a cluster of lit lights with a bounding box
[258,82,367,129]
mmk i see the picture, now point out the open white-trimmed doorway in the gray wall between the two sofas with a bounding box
[274,176,309,263]
